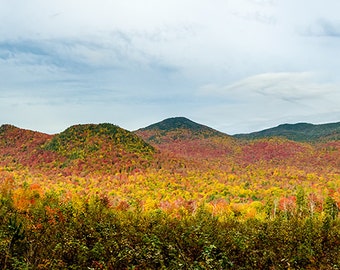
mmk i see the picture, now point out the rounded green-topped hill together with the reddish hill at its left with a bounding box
[0,124,156,174]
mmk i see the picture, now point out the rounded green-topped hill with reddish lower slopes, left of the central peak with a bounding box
[43,123,156,172]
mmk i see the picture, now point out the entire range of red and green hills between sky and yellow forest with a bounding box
[0,117,340,175]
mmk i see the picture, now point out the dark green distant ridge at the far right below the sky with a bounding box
[234,122,340,142]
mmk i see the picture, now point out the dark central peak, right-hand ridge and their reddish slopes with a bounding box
[135,117,340,171]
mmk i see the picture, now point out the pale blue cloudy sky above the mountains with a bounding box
[0,0,340,134]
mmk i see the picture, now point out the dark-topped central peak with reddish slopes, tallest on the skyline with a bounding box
[135,117,235,158]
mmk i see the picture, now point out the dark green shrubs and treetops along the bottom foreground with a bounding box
[0,191,340,269]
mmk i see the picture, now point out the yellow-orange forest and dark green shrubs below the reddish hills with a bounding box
[0,168,340,269]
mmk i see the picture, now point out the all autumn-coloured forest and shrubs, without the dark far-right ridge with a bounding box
[0,119,340,269]
